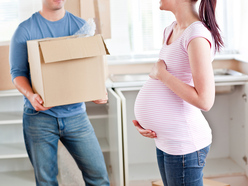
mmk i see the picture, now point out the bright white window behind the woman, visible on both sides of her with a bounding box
[107,0,241,57]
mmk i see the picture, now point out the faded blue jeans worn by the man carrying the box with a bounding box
[23,107,109,186]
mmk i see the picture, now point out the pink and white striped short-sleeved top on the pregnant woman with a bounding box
[134,21,214,155]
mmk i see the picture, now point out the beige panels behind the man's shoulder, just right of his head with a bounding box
[65,0,111,39]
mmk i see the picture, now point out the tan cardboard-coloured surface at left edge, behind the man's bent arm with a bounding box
[0,43,15,90]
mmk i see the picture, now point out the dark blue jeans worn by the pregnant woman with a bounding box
[157,146,210,186]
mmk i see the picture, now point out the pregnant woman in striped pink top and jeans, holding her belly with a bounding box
[133,0,223,186]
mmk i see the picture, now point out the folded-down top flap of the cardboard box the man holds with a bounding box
[39,35,109,63]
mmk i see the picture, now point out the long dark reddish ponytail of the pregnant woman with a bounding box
[193,0,224,51]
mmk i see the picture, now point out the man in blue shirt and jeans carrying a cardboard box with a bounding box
[10,0,109,186]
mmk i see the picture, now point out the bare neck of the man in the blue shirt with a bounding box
[40,7,65,21]
